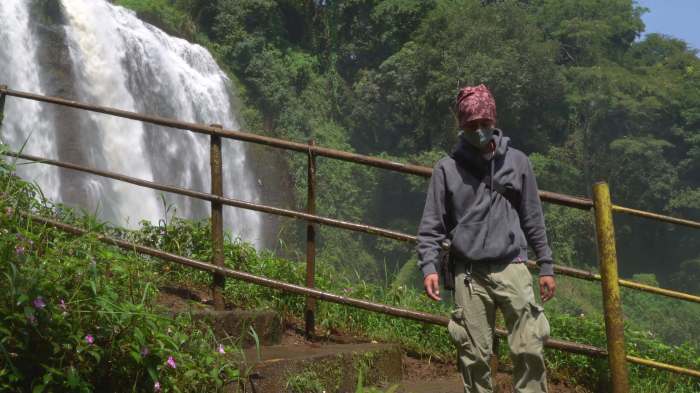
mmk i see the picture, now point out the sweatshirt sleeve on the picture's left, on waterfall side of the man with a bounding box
[416,165,447,276]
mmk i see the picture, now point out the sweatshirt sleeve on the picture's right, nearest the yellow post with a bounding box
[519,156,554,276]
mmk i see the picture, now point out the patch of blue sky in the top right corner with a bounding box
[637,0,700,49]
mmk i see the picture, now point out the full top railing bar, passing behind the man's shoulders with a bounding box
[6,86,700,228]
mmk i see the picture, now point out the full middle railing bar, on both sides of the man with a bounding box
[9,152,700,303]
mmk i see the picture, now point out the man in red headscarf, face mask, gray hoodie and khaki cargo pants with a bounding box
[417,85,555,393]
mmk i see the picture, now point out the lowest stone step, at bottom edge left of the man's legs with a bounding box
[229,343,403,393]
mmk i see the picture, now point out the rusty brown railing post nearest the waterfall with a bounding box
[209,124,226,311]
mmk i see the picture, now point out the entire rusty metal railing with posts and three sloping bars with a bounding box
[0,86,700,392]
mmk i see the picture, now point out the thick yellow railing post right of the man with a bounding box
[593,182,629,393]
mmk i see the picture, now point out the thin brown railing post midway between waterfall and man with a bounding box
[304,139,316,338]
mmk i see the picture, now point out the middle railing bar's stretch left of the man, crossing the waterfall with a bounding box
[3,152,416,242]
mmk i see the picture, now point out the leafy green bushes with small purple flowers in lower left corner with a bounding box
[0,159,238,392]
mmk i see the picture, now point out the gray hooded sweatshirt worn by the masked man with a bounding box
[417,129,554,276]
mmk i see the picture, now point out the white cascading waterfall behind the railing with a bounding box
[0,0,262,245]
